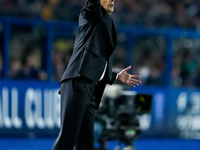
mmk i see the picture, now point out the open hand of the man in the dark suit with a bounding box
[117,66,141,87]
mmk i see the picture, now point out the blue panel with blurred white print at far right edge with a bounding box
[166,88,200,139]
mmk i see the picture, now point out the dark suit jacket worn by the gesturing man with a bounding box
[61,0,117,108]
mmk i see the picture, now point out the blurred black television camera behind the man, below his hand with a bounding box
[97,85,152,150]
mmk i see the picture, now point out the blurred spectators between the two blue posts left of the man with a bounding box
[8,25,47,80]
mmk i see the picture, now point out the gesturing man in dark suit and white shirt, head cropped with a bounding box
[52,0,140,150]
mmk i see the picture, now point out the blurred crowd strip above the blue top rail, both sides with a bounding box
[0,0,200,29]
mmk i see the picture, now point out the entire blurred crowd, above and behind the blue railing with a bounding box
[0,0,200,86]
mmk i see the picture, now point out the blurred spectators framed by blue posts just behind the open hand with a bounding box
[133,36,167,86]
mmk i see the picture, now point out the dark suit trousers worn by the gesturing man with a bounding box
[52,77,96,150]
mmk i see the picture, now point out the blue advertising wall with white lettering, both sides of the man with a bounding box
[0,81,200,139]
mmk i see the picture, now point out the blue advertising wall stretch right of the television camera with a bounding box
[136,87,200,139]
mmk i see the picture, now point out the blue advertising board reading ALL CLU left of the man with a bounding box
[0,81,60,136]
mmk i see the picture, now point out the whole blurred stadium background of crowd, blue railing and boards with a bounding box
[0,0,200,150]
